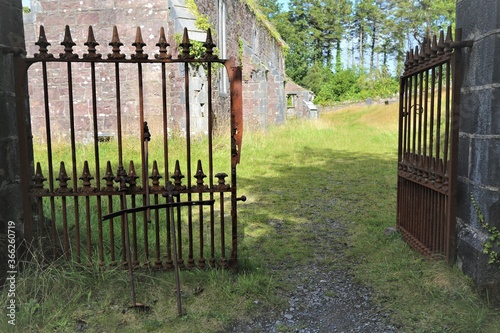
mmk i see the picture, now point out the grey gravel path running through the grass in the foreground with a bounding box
[226,215,399,333]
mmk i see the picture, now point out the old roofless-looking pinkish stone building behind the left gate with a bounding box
[24,0,286,141]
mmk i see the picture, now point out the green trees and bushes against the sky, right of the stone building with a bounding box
[258,0,456,103]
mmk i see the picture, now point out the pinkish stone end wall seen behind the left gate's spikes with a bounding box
[25,0,175,141]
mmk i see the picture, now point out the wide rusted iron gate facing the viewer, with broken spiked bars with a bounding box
[15,26,244,269]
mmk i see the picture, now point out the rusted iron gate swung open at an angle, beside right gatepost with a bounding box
[397,28,470,261]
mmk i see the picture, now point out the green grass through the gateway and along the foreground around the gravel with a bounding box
[0,105,500,333]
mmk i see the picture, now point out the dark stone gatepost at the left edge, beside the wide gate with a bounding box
[0,0,24,286]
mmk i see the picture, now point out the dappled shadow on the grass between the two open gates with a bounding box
[238,147,396,267]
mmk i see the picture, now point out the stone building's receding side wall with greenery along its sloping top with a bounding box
[196,0,286,128]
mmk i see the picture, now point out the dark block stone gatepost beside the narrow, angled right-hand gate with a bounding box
[457,0,500,304]
